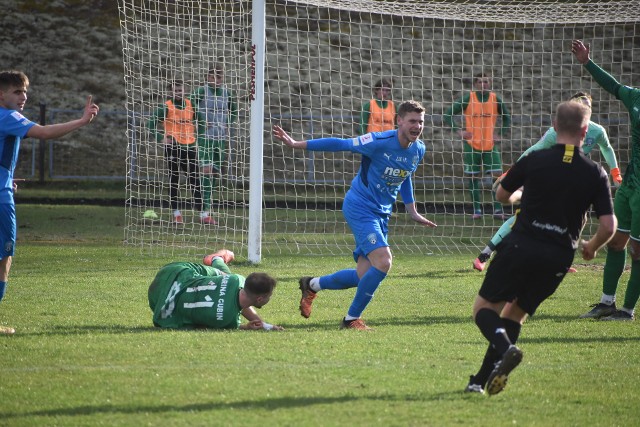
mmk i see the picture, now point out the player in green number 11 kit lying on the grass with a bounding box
[148,249,282,330]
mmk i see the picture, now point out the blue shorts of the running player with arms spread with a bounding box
[342,196,389,262]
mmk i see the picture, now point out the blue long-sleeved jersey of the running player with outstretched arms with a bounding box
[307,130,426,215]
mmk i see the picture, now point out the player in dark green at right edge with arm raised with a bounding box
[571,40,640,320]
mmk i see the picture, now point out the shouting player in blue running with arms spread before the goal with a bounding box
[273,101,436,330]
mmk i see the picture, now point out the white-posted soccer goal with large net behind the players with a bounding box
[119,0,640,262]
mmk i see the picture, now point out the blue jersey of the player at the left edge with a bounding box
[0,107,35,203]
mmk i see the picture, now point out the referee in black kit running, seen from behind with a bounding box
[465,101,617,395]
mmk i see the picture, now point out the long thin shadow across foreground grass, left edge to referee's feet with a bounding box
[0,391,464,420]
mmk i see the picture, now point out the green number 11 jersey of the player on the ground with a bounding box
[149,262,245,329]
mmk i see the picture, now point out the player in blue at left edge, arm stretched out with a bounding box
[0,71,98,335]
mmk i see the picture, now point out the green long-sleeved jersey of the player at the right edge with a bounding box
[584,60,640,188]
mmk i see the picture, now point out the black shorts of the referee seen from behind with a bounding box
[478,233,575,315]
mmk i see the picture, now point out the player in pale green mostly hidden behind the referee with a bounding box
[473,92,622,272]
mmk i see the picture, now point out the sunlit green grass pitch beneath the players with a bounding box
[0,205,640,426]
